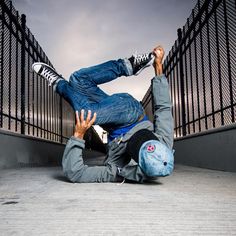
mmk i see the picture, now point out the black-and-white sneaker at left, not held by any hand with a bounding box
[32,62,63,86]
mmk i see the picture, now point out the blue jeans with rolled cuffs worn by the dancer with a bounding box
[56,59,144,130]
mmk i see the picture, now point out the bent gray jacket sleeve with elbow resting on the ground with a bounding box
[62,136,117,183]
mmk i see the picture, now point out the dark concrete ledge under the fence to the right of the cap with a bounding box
[174,124,236,172]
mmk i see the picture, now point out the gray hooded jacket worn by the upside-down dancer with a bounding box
[62,75,173,183]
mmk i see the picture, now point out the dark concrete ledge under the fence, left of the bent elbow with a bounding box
[0,130,65,169]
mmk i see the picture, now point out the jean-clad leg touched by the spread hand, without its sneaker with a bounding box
[56,80,143,130]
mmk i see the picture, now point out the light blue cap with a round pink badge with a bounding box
[139,140,174,177]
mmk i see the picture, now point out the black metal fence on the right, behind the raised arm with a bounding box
[143,0,236,137]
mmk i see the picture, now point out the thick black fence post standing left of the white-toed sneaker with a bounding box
[21,14,26,134]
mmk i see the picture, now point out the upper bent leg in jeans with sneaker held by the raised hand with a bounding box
[64,53,154,102]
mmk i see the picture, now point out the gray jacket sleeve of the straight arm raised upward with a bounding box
[152,75,174,149]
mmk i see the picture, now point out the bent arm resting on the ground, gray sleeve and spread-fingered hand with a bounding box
[62,110,117,183]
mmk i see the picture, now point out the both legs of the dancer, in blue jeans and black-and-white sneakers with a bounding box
[32,54,153,128]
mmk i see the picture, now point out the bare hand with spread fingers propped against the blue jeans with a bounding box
[74,110,97,139]
